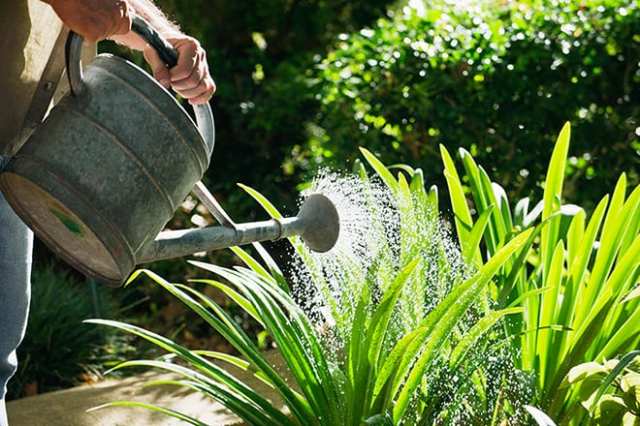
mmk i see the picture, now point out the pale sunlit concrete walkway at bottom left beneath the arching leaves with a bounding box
[7,352,282,426]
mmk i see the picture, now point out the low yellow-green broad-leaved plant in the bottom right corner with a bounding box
[563,350,640,425]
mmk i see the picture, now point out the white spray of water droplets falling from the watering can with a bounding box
[292,171,530,424]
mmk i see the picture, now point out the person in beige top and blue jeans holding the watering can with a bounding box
[0,0,216,426]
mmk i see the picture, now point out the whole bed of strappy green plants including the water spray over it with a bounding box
[96,123,640,425]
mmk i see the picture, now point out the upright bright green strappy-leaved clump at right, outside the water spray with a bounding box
[441,123,640,420]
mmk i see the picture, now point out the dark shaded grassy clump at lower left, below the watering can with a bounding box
[8,265,140,398]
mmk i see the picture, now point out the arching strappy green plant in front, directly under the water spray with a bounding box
[91,156,532,425]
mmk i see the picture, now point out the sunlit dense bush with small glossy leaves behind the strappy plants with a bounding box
[298,0,640,208]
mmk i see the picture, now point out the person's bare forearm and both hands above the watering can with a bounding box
[43,0,216,104]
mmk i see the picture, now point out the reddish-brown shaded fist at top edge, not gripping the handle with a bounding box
[44,0,131,42]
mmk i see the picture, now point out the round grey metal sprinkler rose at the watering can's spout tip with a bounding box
[298,194,340,253]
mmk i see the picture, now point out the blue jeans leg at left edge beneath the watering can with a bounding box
[0,158,33,426]
